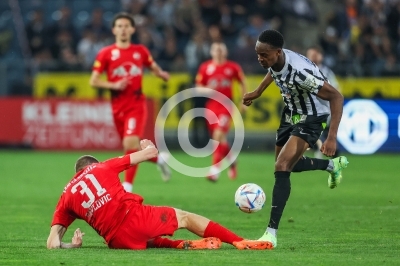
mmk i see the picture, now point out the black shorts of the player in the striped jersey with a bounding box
[275,107,329,147]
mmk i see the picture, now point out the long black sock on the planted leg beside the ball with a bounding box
[268,171,291,229]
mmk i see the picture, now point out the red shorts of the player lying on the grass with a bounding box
[108,204,178,249]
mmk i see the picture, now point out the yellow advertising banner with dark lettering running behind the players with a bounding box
[34,73,400,132]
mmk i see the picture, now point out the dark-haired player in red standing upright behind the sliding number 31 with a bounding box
[90,13,171,192]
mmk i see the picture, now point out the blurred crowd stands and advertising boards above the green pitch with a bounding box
[0,0,400,153]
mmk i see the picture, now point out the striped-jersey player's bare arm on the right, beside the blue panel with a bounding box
[317,82,343,157]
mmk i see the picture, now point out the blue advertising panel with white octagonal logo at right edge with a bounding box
[337,99,400,154]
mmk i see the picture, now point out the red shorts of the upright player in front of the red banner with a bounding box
[114,102,147,139]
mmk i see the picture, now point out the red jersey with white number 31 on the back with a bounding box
[51,155,143,242]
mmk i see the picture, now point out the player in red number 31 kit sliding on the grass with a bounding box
[47,140,272,249]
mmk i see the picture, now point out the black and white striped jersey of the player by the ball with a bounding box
[269,49,330,116]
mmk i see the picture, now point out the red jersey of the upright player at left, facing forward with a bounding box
[93,44,154,114]
